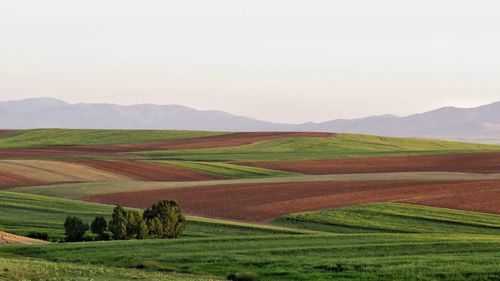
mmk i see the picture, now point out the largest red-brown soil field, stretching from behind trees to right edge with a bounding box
[85,181,500,222]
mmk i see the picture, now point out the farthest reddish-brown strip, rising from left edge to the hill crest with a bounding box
[0,132,334,159]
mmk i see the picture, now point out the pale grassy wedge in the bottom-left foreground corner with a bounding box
[0,258,224,281]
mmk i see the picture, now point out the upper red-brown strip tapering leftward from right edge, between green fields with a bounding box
[239,153,500,175]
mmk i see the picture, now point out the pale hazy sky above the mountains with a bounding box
[0,0,500,123]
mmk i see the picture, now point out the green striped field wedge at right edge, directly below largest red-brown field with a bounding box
[274,203,500,233]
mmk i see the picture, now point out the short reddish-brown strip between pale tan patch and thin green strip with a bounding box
[72,160,225,181]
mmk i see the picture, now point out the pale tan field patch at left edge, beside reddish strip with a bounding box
[0,160,128,183]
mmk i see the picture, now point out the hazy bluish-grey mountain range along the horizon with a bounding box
[0,98,500,142]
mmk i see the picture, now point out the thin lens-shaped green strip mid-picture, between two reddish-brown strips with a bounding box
[152,161,295,179]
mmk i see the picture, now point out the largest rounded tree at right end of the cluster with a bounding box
[143,200,186,238]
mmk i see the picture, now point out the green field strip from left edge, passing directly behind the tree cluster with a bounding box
[0,191,303,240]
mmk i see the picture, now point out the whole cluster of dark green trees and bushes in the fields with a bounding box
[64,200,186,242]
